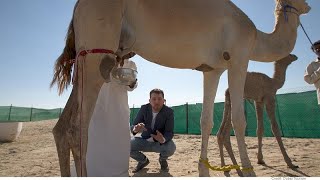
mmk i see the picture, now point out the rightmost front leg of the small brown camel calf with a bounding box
[266,97,298,168]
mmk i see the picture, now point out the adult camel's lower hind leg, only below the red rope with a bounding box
[67,54,115,177]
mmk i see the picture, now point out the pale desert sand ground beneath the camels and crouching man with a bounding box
[0,120,320,177]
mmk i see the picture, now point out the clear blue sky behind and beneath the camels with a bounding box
[0,0,320,108]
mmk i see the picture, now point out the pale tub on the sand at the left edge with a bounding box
[0,122,22,142]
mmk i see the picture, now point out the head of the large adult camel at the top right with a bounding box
[275,0,311,15]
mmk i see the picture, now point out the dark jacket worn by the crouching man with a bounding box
[131,103,174,143]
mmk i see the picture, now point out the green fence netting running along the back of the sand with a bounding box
[0,91,320,138]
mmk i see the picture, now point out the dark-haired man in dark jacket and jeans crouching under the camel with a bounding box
[130,89,176,173]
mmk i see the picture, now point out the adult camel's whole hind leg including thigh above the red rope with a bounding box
[73,0,123,176]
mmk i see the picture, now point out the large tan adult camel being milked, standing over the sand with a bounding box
[53,0,311,176]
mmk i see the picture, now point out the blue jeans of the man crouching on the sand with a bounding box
[130,137,176,162]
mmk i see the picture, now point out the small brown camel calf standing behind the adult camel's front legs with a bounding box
[217,54,298,175]
